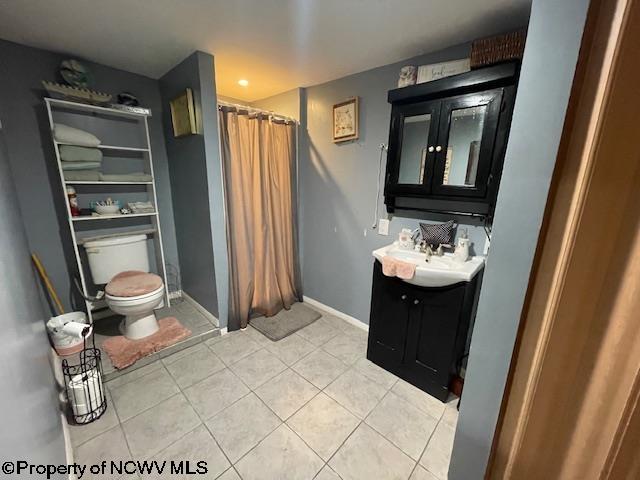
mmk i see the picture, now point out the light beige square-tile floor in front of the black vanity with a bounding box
[70,304,457,480]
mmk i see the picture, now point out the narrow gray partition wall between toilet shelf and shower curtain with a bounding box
[160,52,224,316]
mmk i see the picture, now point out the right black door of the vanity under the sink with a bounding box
[403,284,465,401]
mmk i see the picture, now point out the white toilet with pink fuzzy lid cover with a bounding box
[84,235,164,340]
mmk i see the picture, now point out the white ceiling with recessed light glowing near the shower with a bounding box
[0,0,531,101]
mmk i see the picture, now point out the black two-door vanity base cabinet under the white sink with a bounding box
[367,260,482,401]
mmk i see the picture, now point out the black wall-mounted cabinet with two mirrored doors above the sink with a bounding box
[384,62,519,217]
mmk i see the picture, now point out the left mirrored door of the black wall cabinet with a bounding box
[385,100,441,195]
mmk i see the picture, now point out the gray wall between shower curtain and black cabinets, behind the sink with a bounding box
[299,44,486,323]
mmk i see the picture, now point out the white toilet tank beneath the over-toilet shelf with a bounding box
[84,235,149,285]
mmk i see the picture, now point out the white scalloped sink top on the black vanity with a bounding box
[373,245,484,287]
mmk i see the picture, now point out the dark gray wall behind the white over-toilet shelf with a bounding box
[0,40,178,314]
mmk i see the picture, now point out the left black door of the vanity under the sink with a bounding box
[367,261,411,366]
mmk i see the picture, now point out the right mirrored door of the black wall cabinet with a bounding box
[431,88,503,197]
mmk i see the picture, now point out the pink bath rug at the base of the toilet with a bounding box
[102,317,191,370]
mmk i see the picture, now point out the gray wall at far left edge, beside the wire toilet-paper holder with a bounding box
[0,124,66,478]
